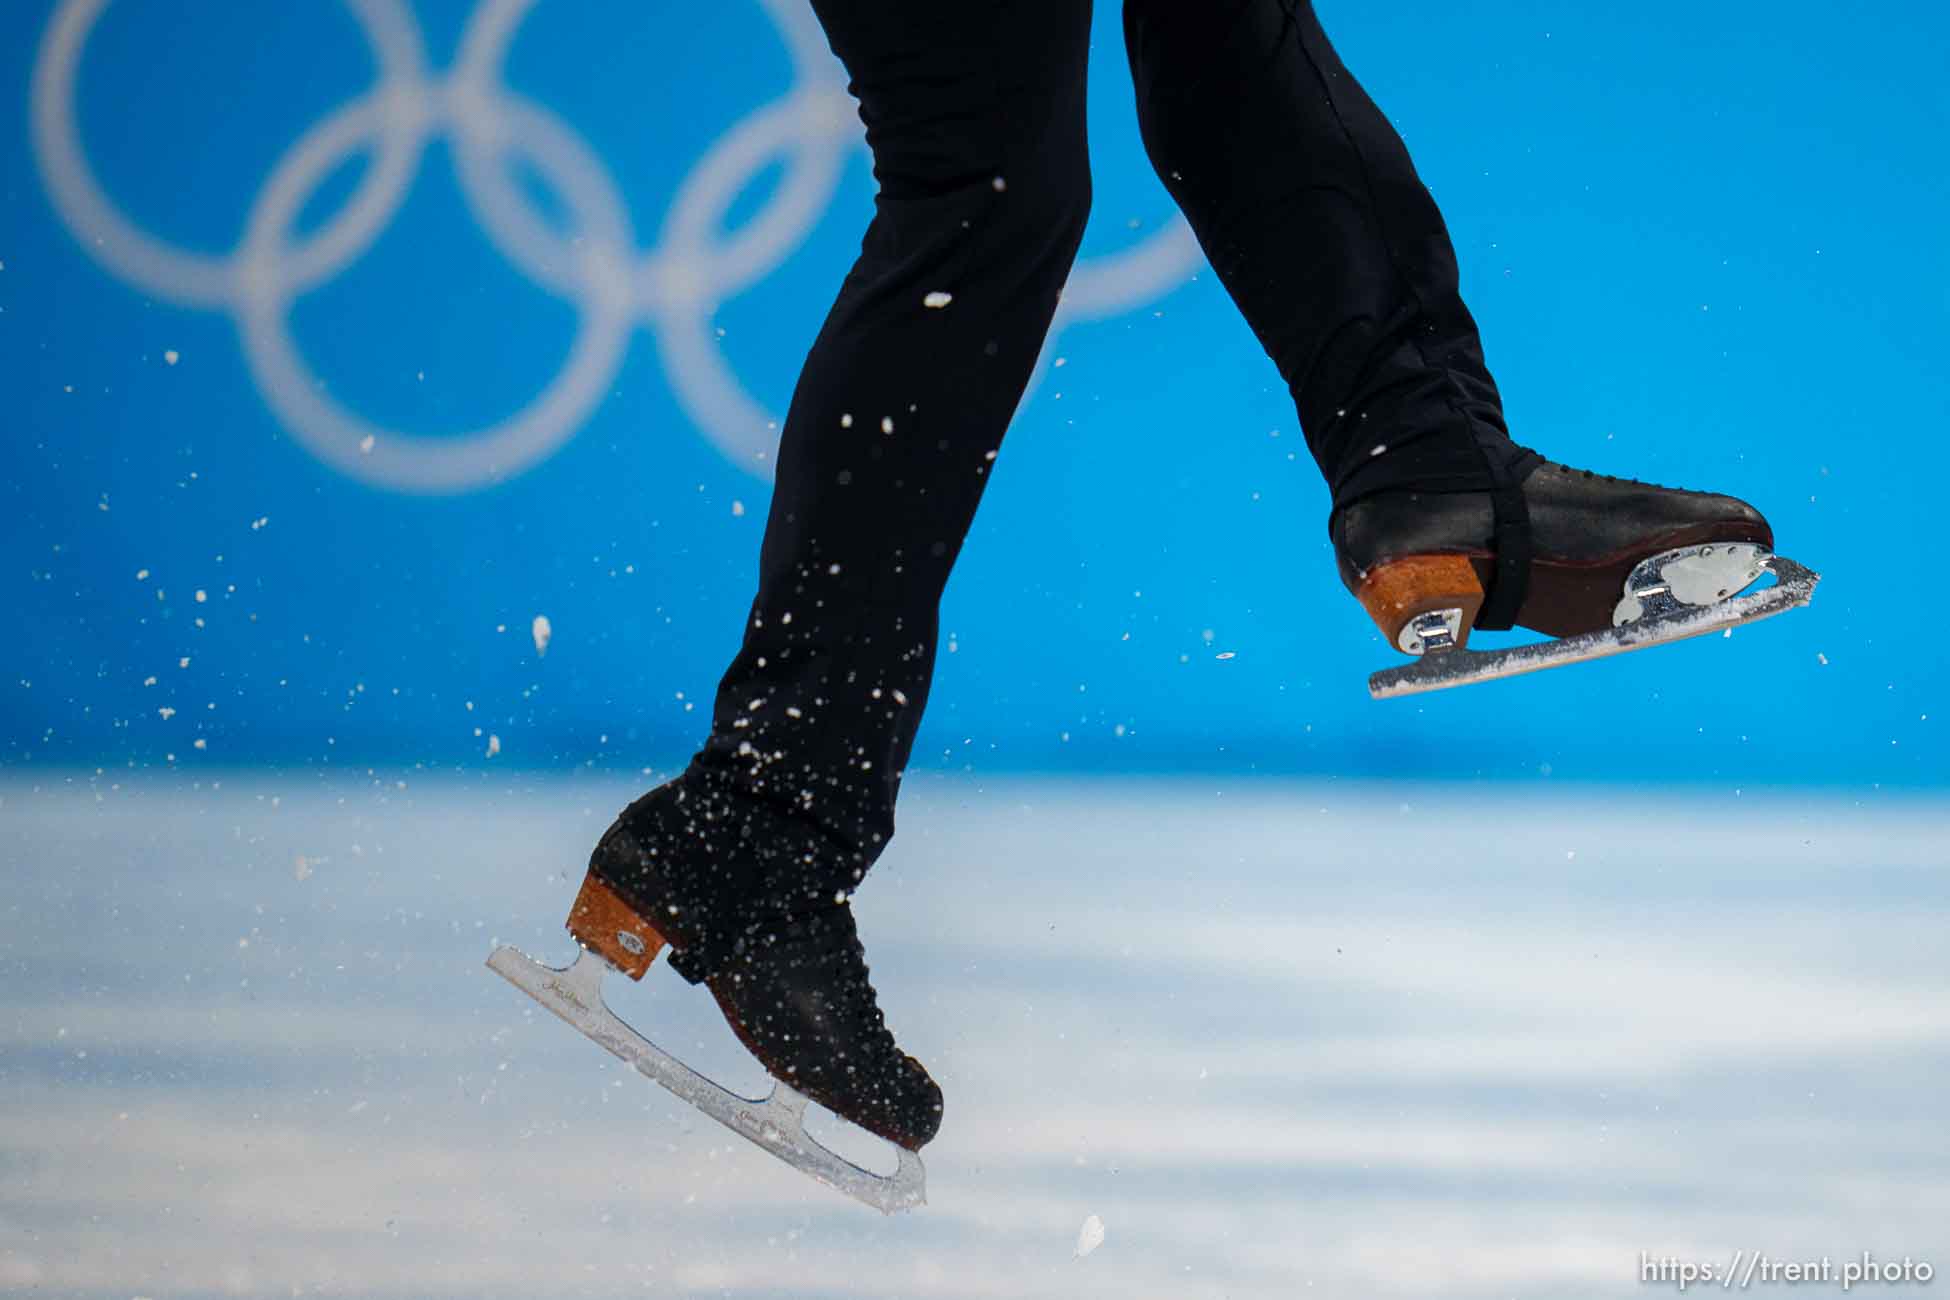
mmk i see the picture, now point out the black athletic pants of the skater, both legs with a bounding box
[653,0,1507,916]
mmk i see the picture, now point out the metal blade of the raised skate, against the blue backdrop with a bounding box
[1367,555,1821,700]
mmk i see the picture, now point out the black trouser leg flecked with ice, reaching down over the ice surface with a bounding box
[670,0,1090,912]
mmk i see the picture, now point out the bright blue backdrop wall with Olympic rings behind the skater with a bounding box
[0,0,1950,787]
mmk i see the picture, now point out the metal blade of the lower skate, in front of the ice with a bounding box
[488,947,928,1214]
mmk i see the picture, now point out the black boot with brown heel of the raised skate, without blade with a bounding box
[1328,448,1775,655]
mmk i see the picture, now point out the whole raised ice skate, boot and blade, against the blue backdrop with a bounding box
[1330,462,1819,700]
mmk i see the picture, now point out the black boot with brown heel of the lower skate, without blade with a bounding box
[569,778,942,1150]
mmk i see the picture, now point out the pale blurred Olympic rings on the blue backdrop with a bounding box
[31,0,1199,493]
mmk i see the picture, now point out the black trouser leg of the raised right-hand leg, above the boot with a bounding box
[1123,0,1515,505]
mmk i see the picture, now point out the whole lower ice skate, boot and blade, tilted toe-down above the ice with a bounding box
[488,791,942,1212]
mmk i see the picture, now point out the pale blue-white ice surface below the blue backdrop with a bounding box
[0,779,1950,1300]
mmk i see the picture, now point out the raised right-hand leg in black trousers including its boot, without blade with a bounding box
[1123,0,1773,653]
